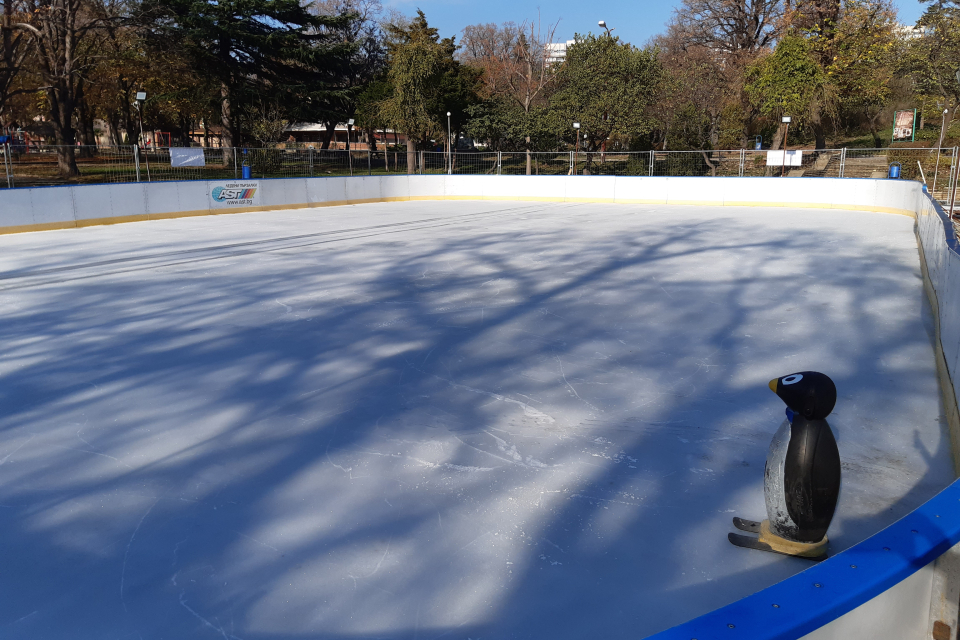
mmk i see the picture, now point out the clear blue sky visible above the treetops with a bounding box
[384,0,923,45]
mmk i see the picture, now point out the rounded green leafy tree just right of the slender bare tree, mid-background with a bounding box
[551,34,662,171]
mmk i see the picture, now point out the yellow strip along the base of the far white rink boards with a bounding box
[0,195,916,235]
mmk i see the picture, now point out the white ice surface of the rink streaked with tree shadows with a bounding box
[0,201,954,640]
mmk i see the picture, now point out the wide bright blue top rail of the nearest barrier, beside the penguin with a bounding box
[648,480,960,640]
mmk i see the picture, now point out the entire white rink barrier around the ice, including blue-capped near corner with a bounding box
[0,175,960,640]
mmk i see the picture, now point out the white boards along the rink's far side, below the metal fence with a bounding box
[0,175,921,233]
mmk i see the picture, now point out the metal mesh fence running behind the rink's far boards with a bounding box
[0,144,958,202]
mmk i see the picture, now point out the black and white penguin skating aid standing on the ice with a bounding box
[730,371,840,559]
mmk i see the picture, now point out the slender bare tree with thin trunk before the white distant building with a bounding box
[461,18,559,175]
